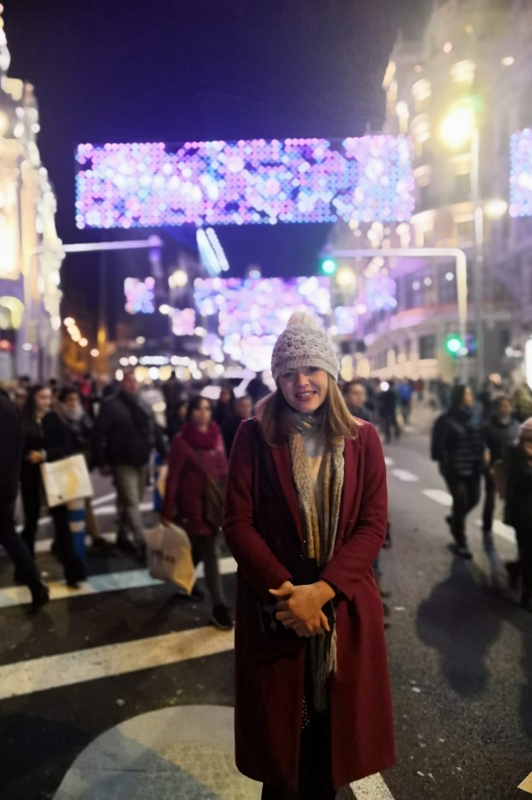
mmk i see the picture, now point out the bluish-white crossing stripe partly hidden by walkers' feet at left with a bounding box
[0,556,237,608]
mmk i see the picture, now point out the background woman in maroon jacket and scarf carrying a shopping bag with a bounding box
[162,397,233,630]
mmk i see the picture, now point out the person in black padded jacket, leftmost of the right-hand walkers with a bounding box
[432,384,484,559]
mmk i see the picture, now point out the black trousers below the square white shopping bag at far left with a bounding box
[21,469,85,583]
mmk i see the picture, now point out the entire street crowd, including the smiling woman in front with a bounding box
[0,324,532,800]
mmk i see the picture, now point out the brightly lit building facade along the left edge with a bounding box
[0,12,64,381]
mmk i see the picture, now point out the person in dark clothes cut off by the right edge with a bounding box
[504,417,532,611]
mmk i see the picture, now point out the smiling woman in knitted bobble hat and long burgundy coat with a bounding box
[223,314,395,800]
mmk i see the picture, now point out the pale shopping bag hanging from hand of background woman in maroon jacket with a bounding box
[144,524,196,594]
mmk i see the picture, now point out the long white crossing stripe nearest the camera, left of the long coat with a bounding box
[0,627,234,700]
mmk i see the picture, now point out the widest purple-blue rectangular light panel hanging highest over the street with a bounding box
[76,136,414,228]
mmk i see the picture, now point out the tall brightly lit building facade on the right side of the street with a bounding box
[331,0,532,383]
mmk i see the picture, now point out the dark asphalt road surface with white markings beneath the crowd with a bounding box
[0,427,532,800]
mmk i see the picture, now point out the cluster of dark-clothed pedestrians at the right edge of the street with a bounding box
[431,381,532,611]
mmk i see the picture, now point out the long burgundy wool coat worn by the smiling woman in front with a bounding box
[223,420,395,792]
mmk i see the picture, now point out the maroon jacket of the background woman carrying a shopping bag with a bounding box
[162,426,227,536]
